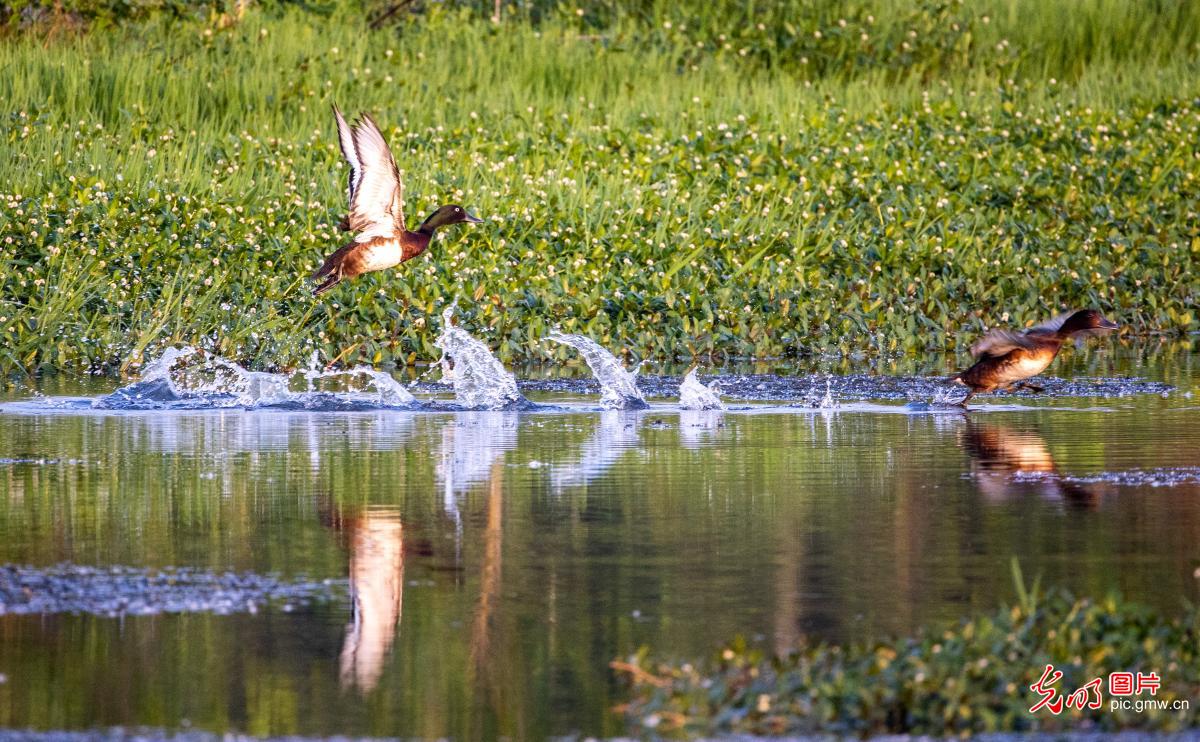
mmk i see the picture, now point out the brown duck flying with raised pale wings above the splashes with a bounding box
[312,106,484,295]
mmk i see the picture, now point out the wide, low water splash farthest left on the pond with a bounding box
[92,347,418,411]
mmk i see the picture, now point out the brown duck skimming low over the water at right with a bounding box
[950,310,1117,407]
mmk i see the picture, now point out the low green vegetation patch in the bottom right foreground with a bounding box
[612,583,1200,736]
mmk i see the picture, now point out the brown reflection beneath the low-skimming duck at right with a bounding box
[959,420,1099,509]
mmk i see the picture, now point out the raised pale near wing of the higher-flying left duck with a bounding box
[347,114,404,243]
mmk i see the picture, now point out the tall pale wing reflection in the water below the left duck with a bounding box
[341,508,404,693]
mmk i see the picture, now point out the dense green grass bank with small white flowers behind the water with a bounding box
[0,0,1200,370]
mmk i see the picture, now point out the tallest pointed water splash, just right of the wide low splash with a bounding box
[433,305,529,409]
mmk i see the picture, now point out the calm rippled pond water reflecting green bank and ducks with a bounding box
[0,355,1200,738]
